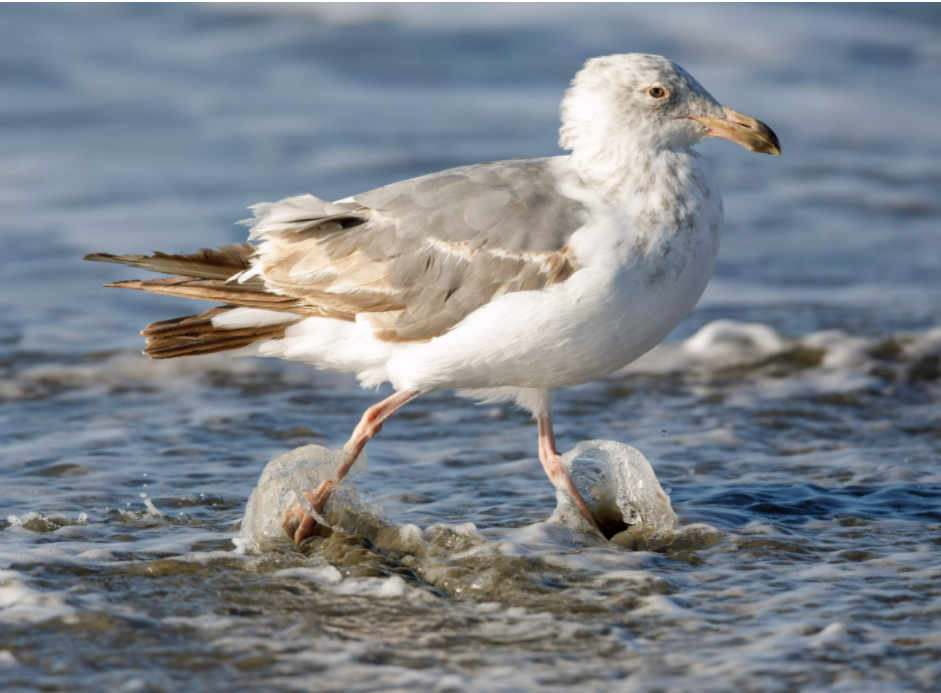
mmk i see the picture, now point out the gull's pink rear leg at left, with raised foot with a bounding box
[282,392,421,544]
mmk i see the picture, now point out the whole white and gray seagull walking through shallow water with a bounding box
[85,53,781,544]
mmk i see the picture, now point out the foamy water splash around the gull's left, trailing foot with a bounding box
[239,445,375,551]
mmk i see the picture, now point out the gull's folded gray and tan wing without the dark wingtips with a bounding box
[252,159,588,341]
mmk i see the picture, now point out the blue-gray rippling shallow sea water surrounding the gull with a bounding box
[0,5,941,693]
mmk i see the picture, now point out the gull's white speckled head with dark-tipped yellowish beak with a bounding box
[559,53,781,164]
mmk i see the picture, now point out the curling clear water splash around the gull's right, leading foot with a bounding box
[553,440,676,539]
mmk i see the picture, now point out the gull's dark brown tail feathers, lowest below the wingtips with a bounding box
[141,306,304,360]
